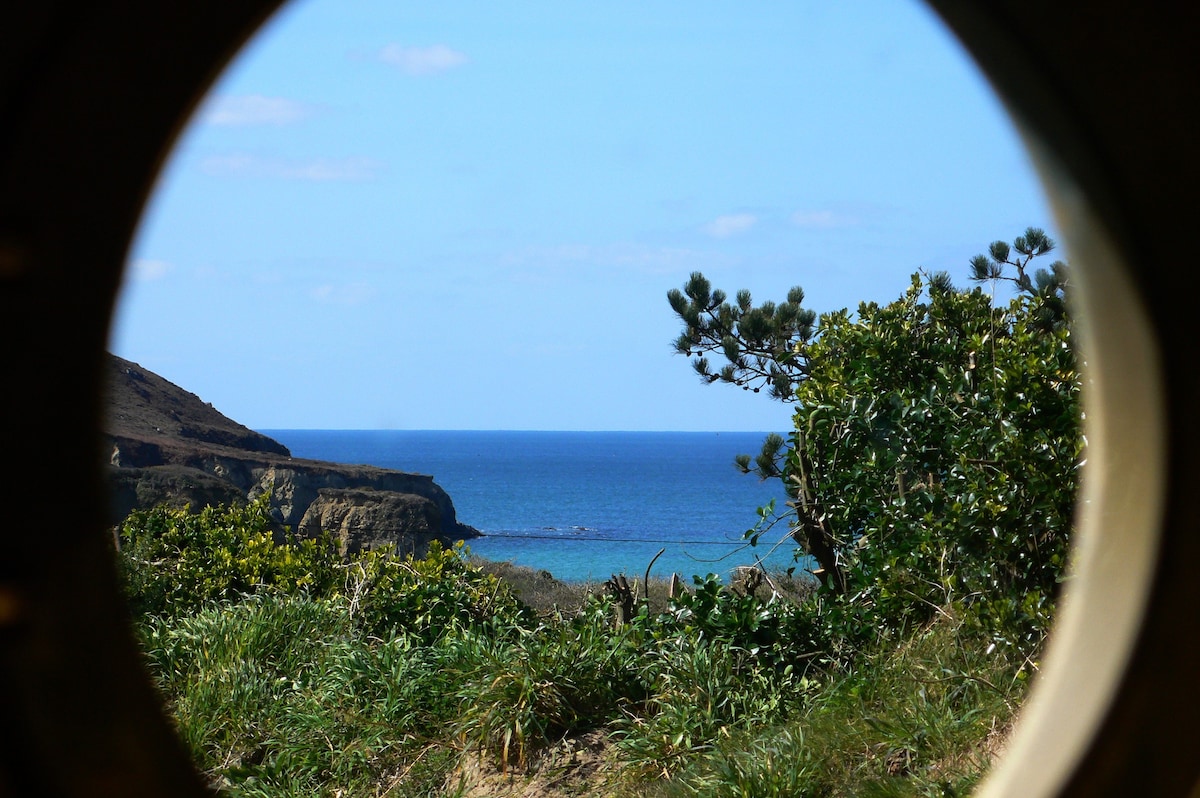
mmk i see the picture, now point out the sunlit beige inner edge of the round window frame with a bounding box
[979,147,1166,798]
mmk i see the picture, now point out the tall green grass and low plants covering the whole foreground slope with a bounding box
[119,513,1030,798]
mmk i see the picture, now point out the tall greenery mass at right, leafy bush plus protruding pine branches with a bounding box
[668,228,1084,665]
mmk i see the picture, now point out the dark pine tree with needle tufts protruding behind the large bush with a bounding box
[667,227,1069,594]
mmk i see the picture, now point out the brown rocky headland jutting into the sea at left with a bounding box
[106,355,479,554]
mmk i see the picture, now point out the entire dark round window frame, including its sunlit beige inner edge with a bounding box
[0,0,1200,798]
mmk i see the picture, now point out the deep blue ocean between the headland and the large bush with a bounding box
[262,430,794,582]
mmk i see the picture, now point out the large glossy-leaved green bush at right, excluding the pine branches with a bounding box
[784,275,1082,653]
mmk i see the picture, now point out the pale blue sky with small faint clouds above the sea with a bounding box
[110,0,1055,431]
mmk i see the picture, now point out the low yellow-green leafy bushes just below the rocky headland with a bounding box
[118,494,533,638]
